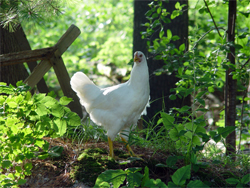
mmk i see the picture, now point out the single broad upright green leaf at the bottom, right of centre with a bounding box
[172,165,191,185]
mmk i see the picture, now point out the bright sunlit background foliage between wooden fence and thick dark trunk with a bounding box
[23,0,133,96]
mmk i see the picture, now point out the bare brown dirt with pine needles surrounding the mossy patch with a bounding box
[21,138,175,188]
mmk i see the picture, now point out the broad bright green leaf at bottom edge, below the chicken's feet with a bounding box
[95,169,127,188]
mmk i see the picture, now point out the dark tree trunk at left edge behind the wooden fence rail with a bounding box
[0,26,29,85]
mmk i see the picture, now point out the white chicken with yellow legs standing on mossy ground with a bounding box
[70,51,149,158]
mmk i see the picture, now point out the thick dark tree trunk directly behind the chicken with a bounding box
[133,0,188,125]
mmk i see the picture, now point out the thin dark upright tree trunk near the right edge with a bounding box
[225,0,237,159]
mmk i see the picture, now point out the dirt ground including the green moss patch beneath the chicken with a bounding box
[20,138,249,188]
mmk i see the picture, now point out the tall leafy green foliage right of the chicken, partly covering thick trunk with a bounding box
[141,1,250,157]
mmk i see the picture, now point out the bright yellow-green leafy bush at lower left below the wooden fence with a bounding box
[0,81,80,187]
